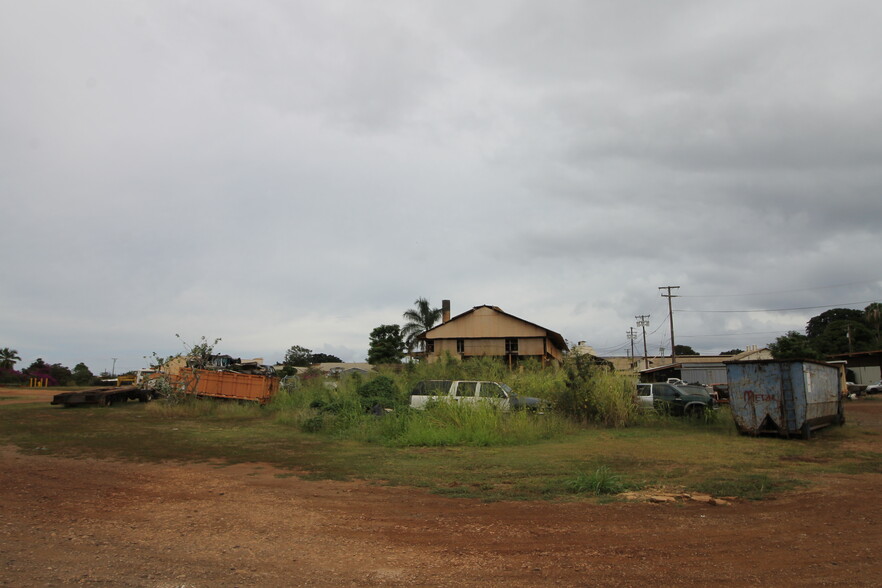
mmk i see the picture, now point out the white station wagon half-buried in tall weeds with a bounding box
[410,380,549,412]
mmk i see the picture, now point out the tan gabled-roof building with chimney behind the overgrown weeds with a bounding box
[417,300,567,367]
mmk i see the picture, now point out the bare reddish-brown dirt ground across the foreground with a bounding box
[0,388,882,587]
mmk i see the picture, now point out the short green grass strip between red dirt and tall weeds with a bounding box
[0,382,868,500]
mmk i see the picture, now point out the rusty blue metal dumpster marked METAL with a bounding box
[726,360,845,439]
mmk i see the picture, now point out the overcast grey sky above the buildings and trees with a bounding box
[0,0,882,373]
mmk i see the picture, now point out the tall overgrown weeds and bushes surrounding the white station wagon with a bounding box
[150,357,652,447]
